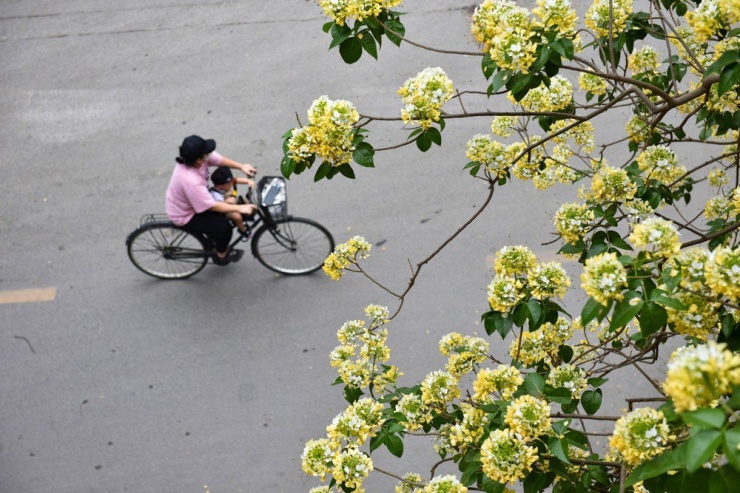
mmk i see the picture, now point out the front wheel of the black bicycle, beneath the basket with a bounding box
[252,217,334,276]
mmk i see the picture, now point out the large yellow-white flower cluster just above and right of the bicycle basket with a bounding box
[288,96,360,166]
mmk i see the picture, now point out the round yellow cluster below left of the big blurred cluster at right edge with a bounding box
[609,407,674,466]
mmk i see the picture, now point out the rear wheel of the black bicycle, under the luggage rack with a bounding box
[126,222,210,279]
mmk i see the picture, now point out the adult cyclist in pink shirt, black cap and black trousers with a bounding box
[166,135,257,265]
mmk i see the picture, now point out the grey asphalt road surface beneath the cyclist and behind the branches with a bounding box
[0,0,704,493]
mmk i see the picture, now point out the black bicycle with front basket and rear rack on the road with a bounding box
[126,176,334,279]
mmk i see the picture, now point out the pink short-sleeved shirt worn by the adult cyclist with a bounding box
[166,152,223,226]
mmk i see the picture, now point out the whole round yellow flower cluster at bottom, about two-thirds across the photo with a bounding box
[480,429,538,483]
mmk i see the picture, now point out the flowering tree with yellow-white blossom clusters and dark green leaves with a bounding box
[292,0,740,493]
